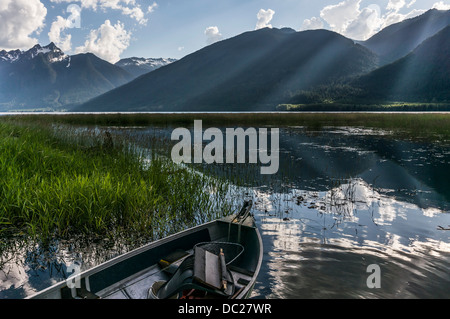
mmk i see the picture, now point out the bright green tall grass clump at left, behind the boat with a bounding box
[0,119,229,242]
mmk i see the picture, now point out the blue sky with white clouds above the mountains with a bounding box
[0,0,450,63]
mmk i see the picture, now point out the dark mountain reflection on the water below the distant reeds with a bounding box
[194,127,450,210]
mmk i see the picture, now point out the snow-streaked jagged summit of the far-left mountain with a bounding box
[0,42,69,63]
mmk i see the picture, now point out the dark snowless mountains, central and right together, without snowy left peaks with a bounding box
[75,9,450,111]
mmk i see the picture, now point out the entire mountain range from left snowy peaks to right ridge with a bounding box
[0,9,450,112]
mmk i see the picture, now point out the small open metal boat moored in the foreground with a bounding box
[28,201,263,299]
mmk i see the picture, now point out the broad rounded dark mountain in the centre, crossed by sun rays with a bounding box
[77,28,378,111]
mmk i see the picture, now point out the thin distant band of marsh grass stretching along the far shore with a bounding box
[0,111,450,142]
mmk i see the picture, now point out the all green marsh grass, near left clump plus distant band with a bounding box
[0,112,450,242]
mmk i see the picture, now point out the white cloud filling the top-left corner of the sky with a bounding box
[0,0,47,49]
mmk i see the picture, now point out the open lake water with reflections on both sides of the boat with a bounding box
[0,127,450,299]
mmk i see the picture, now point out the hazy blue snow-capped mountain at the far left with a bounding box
[0,43,134,111]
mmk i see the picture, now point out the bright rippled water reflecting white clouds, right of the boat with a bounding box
[254,179,450,298]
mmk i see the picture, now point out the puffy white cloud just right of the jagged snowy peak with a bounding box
[76,20,131,63]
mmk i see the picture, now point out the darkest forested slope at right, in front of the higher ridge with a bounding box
[285,26,450,105]
